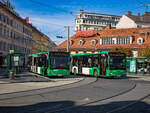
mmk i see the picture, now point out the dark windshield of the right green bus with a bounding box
[110,56,126,69]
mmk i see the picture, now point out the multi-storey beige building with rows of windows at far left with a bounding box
[0,2,33,69]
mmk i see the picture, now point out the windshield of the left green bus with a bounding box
[50,56,69,69]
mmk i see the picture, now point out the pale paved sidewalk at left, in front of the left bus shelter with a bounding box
[0,72,84,94]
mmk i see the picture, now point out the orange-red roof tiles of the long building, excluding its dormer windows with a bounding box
[56,27,150,50]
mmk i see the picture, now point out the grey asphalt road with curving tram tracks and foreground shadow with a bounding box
[0,74,150,113]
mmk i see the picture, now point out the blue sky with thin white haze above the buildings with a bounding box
[10,0,150,44]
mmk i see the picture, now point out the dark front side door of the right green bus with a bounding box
[100,54,107,75]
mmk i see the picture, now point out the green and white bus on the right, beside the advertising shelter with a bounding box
[71,51,126,77]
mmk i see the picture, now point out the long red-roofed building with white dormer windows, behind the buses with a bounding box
[56,27,150,56]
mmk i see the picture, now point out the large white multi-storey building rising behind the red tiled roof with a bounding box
[75,10,121,31]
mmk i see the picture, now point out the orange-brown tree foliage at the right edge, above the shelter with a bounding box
[138,47,150,57]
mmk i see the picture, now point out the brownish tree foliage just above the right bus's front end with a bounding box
[112,48,133,57]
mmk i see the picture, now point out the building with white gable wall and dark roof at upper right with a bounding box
[116,12,150,29]
